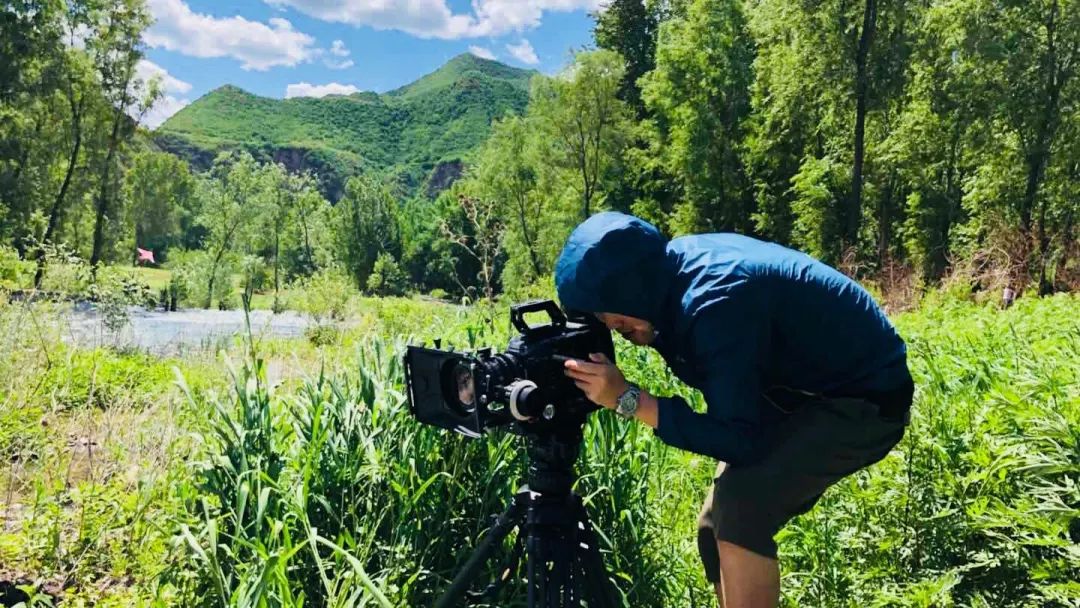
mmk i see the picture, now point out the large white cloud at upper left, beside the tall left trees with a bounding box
[143,0,320,70]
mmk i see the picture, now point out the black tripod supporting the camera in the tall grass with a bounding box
[435,424,624,608]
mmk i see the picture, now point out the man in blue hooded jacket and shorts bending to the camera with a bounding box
[555,213,914,608]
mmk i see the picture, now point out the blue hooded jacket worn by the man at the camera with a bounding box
[555,212,910,464]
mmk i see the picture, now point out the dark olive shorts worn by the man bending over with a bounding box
[698,398,907,583]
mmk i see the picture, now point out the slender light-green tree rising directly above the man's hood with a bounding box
[528,51,631,219]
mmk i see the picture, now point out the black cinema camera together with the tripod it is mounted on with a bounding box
[405,300,625,608]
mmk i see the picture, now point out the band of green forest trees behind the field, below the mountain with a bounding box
[0,0,1080,306]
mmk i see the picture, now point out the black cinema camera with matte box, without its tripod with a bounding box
[405,300,615,437]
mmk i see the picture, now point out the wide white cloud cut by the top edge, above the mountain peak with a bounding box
[264,0,604,39]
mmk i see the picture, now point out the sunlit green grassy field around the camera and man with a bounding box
[0,295,1080,608]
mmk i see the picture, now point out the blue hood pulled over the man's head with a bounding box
[555,212,673,325]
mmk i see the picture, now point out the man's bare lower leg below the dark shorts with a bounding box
[716,540,780,608]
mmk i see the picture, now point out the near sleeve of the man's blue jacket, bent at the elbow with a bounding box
[656,283,770,464]
